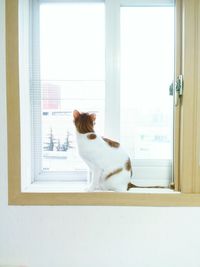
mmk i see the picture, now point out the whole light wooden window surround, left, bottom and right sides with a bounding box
[6,0,200,206]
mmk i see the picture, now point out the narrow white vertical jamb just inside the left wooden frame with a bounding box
[19,0,32,191]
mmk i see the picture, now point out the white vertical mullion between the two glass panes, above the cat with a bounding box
[105,0,120,140]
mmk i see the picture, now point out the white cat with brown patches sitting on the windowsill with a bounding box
[73,110,166,192]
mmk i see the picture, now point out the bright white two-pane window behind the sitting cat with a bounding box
[19,0,174,191]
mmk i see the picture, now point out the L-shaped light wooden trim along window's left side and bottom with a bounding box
[6,0,200,207]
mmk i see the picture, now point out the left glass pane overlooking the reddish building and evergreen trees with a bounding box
[40,3,105,175]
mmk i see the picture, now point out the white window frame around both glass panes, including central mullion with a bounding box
[24,0,174,188]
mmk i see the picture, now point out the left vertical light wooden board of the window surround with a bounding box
[5,0,21,205]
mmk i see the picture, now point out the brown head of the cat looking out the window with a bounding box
[73,110,96,134]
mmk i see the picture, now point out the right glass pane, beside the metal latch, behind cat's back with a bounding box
[121,7,174,162]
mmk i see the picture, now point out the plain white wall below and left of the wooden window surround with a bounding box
[0,0,200,267]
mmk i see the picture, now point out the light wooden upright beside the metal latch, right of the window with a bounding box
[180,0,200,194]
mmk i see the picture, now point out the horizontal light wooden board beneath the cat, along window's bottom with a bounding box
[9,192,200,207]
